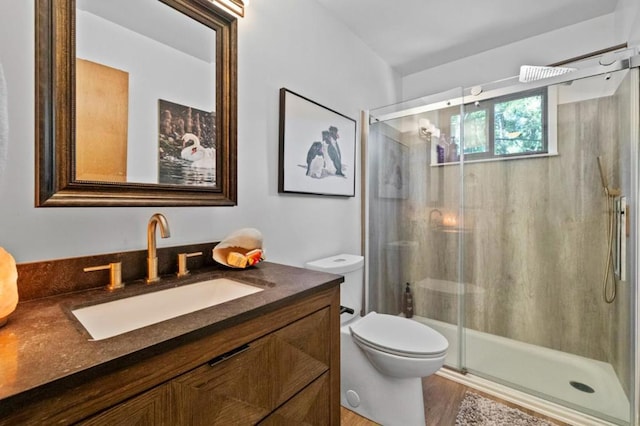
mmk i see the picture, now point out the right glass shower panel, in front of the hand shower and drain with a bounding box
[462,63,638,424]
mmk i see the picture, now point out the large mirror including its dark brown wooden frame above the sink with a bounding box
[36,0,237,207]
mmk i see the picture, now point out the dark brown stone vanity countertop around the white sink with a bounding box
[0,262,343,405]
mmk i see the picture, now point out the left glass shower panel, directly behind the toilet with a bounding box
[367,88,465,369]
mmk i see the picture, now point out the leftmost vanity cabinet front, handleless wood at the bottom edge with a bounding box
[79,385,173,426]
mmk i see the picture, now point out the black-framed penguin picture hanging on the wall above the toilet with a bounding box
[278,88,356,197]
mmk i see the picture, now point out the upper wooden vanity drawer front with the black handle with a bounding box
[171,309,330,426]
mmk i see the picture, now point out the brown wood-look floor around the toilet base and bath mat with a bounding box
[341,374,566,426]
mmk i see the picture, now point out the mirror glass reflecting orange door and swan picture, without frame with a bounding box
[75,0,216,187]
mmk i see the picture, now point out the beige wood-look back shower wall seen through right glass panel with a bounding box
[458,99,616,361]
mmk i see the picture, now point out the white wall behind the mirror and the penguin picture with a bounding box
[0,0,400,265]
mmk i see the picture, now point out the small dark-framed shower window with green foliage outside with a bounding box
[450,89,548,160]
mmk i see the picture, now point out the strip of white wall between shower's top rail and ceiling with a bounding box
[402,13,624,99]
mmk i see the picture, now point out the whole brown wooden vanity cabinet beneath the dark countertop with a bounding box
[0,287,340,426]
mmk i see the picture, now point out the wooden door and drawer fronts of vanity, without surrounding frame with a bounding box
[81,300,331,426]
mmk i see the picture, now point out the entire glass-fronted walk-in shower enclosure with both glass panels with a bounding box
[366,49,640,425]
